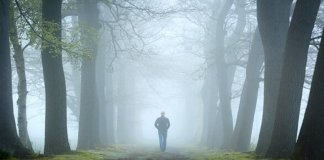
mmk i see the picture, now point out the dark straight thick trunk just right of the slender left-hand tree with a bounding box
[41,0,70,154]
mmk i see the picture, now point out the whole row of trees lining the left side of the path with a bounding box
[0,0,161,155]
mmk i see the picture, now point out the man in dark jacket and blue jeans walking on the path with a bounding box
[154,112,170,152]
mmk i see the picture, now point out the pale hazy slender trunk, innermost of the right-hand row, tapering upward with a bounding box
[201,0,223,148]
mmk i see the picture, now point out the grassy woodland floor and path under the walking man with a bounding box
[5,145,288,160]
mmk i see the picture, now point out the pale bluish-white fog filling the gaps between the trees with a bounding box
[7,0,320,153]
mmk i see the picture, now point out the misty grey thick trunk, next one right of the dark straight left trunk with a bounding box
[77,0,101,149]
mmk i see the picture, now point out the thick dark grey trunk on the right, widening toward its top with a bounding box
[256,0,292,155]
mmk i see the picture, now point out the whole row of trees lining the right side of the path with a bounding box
[195,0,323,159]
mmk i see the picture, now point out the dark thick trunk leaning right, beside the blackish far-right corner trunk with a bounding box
[266,0,320,158]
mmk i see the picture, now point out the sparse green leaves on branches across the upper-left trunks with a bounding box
[13,0,97,65]
